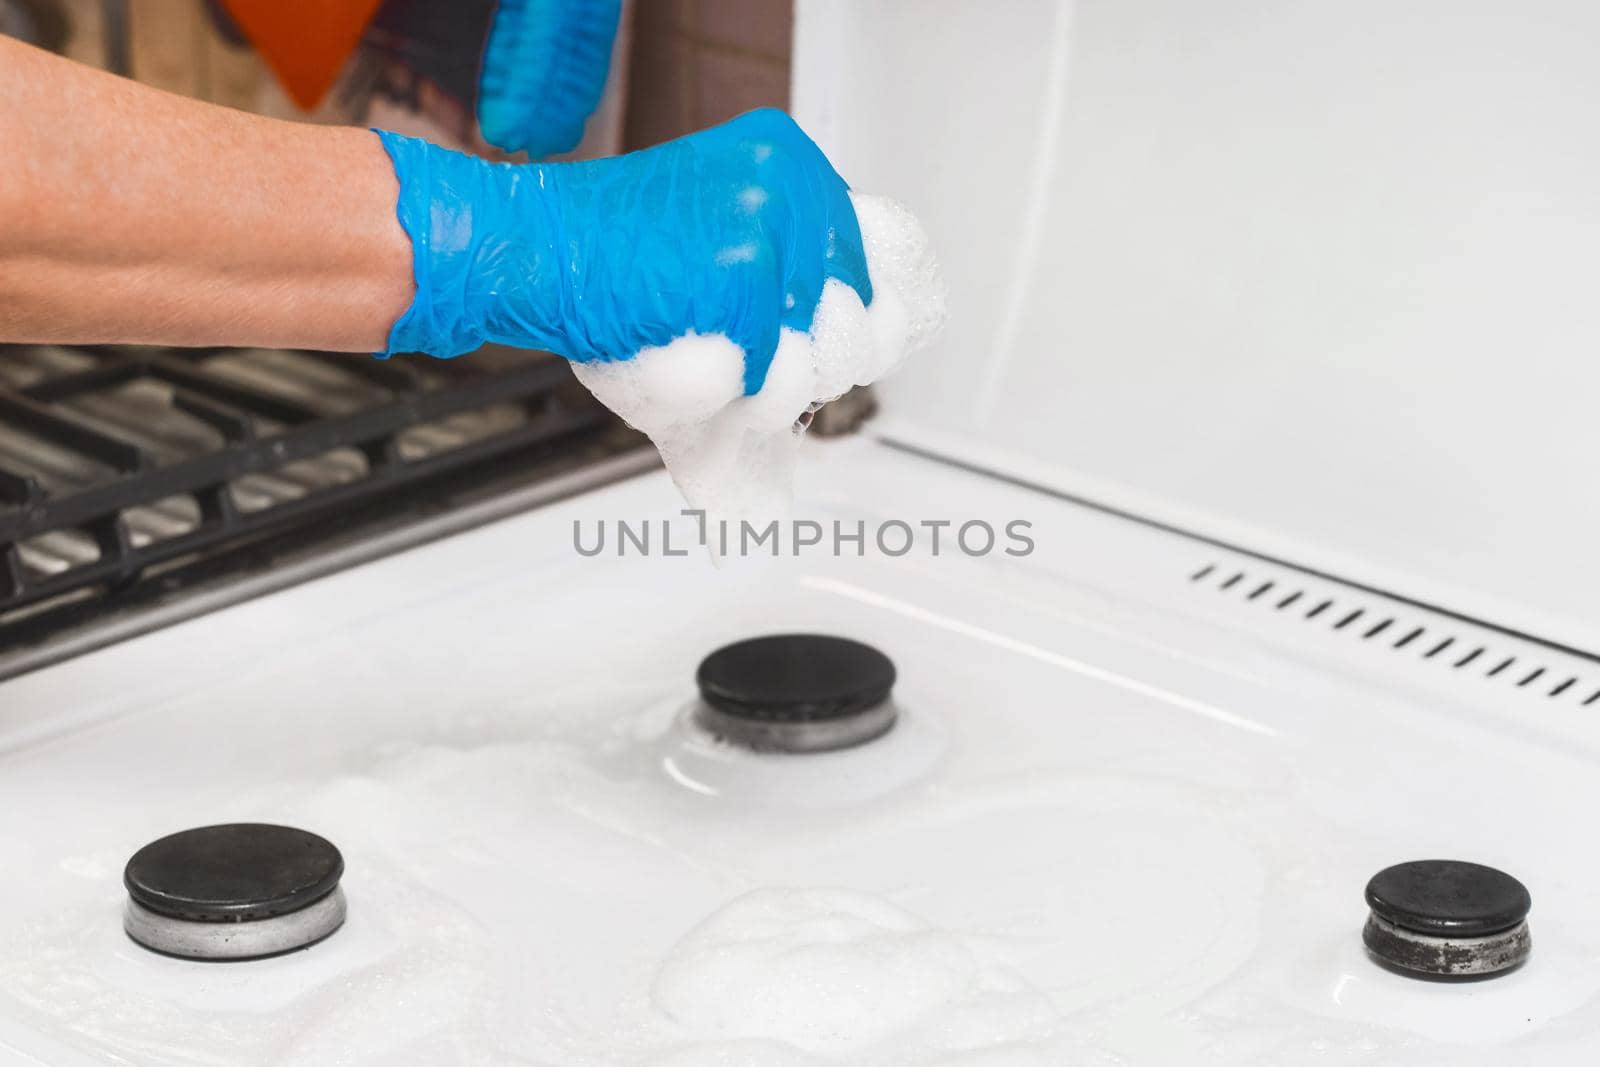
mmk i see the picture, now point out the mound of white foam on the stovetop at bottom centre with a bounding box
[653,888,1056,1067]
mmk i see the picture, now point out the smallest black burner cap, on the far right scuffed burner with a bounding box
[1366,859,1533,937]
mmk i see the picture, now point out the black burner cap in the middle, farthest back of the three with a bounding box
[696,633,894,723]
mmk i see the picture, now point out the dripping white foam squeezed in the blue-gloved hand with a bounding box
[573,194,946,534]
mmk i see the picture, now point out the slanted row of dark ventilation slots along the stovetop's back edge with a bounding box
[1189,563,1600,707]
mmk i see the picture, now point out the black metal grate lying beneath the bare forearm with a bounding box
[0,346,616,630]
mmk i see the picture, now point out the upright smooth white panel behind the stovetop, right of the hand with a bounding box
[794,0,1600,648]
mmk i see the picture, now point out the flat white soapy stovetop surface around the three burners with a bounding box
[0,442,1600,1067]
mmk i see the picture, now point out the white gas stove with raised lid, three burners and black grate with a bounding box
[12,0,1600,1067]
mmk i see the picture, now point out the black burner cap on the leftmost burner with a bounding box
[122,822,344,923]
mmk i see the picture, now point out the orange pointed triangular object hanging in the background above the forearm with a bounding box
[222,0,382,110]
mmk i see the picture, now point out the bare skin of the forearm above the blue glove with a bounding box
[0,37,413,352]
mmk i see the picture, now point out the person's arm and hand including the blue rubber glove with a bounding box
[0,38,872,394]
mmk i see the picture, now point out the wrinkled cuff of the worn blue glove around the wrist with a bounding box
[373,130,485,358]
